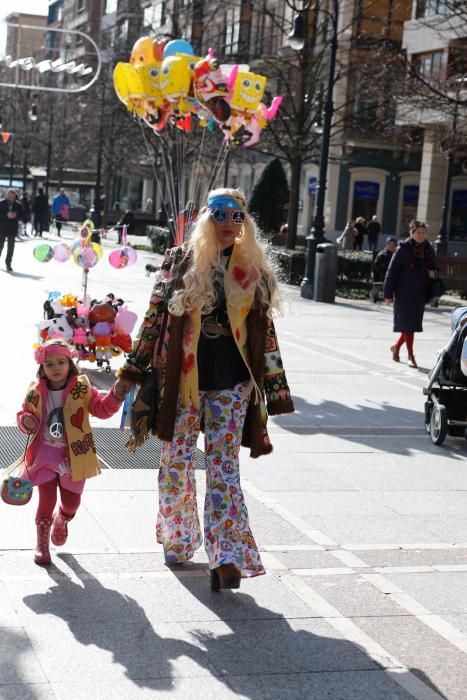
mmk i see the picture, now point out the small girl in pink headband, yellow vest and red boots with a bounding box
[17,339,128,566]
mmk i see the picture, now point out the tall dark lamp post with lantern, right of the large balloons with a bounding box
[288,0,339,299]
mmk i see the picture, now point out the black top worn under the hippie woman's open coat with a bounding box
[197,246,250,391]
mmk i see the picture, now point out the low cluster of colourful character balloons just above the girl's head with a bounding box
[38,292,137,371]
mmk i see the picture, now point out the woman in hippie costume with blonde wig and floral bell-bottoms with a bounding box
[119,189,294,590]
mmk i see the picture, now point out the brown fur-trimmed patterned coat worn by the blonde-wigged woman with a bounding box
[119,243,294,457]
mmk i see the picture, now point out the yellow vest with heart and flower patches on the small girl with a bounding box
[26,375,101,481]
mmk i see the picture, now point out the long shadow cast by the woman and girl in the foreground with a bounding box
[19,555,450,700]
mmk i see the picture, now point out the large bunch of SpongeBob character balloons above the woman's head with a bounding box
[113,37,282,147]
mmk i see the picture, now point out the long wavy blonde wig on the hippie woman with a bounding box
[169,188,280,317]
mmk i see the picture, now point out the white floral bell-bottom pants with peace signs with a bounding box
[156,382,265,577]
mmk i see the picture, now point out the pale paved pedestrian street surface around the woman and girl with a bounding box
[0,229,467,700]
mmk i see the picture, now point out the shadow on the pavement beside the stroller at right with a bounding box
[273,396,467,461]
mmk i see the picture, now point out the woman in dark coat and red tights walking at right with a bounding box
[383,219,437,368]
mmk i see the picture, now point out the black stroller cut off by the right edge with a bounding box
[423,306,467,445]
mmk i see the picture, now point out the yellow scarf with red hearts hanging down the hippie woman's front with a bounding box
[180,245,261,409]
